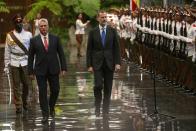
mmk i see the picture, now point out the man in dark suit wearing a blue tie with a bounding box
[86,11,121,117]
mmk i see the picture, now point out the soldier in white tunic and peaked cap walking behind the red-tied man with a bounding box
[4,14,32,114]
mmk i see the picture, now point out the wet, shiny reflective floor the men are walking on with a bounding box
[0,46,196,131]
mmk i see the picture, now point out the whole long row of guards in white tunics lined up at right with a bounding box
[105,6,196,93]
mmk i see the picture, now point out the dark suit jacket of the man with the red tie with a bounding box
[28,34,67,75]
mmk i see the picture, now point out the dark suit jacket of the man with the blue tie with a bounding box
[86,26,121,70]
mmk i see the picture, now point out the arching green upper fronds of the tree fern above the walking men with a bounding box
[26,0,100,20]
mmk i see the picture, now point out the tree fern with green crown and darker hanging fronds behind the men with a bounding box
[25,0,100,43]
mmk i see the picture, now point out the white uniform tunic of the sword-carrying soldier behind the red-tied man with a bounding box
[4,30,32,70]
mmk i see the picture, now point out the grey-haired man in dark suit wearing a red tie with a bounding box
[28,18,67,123]
